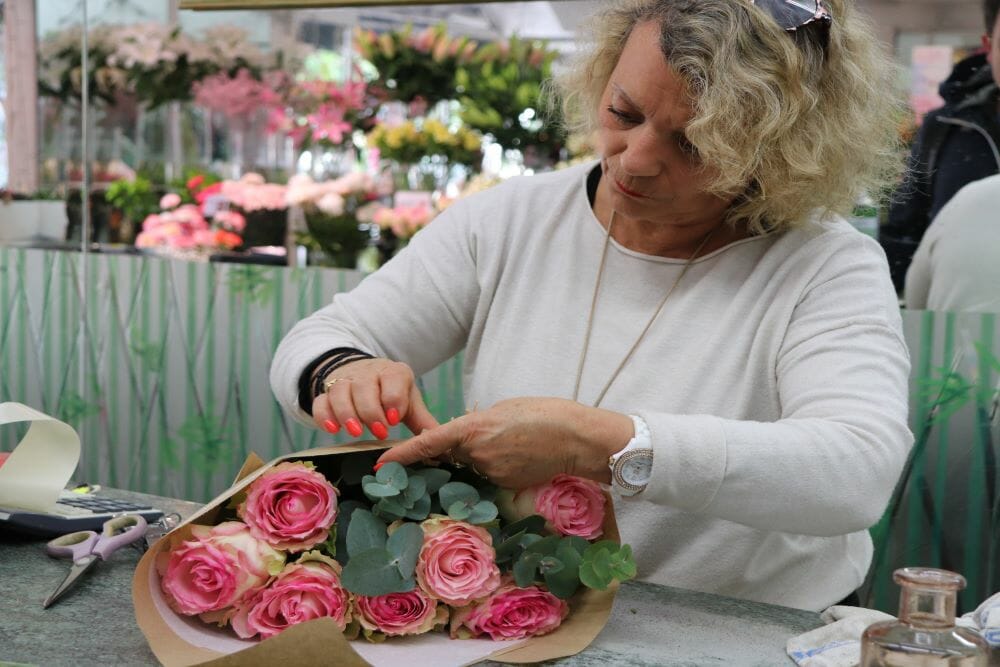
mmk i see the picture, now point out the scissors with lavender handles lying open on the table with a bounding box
[42,514,147,609]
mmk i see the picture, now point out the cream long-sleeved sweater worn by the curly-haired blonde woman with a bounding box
[271,164,912,610]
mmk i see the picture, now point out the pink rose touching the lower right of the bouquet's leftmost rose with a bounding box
[230,551,351,639]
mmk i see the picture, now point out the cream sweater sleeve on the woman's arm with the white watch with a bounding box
[642,235,913,536]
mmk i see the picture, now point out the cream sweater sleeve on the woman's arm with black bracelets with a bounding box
[270,201,480,424]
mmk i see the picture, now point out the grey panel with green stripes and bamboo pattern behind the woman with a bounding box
[0,247,1000,611]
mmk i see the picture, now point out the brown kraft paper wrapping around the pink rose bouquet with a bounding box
[132,442,620,667]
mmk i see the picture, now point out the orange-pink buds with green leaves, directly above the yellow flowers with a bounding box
[354,24,477,116]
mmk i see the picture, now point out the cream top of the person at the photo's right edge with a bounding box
[903,175,1000,312]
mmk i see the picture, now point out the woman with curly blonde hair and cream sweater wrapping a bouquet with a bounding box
[271,0,912,609]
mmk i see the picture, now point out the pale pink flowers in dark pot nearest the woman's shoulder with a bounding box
[286,172,380,269]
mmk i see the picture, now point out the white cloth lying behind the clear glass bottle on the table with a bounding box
[785,593,1000,667]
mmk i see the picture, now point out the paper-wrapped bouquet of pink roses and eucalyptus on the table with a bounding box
[133,443,635,665]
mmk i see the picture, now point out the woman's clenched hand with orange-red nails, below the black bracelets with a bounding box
[312,359,438,440]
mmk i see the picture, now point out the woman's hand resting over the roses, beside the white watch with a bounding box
[378,398,633,489]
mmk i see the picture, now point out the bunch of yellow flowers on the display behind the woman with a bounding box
[368,118,482,191]
